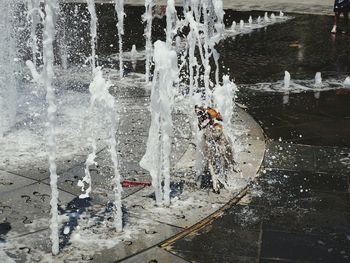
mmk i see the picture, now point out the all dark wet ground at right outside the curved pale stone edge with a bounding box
[160,11,350,262]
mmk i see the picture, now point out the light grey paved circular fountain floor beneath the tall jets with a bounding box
[0,76,265,262]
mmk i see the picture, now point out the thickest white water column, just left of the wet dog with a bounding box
[140,40,179,206]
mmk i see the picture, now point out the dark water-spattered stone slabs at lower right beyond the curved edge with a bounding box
[168,142,350,262]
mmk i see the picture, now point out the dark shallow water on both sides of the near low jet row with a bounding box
[220,13,350,147]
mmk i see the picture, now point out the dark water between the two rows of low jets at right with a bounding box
[220,11,350,84]
